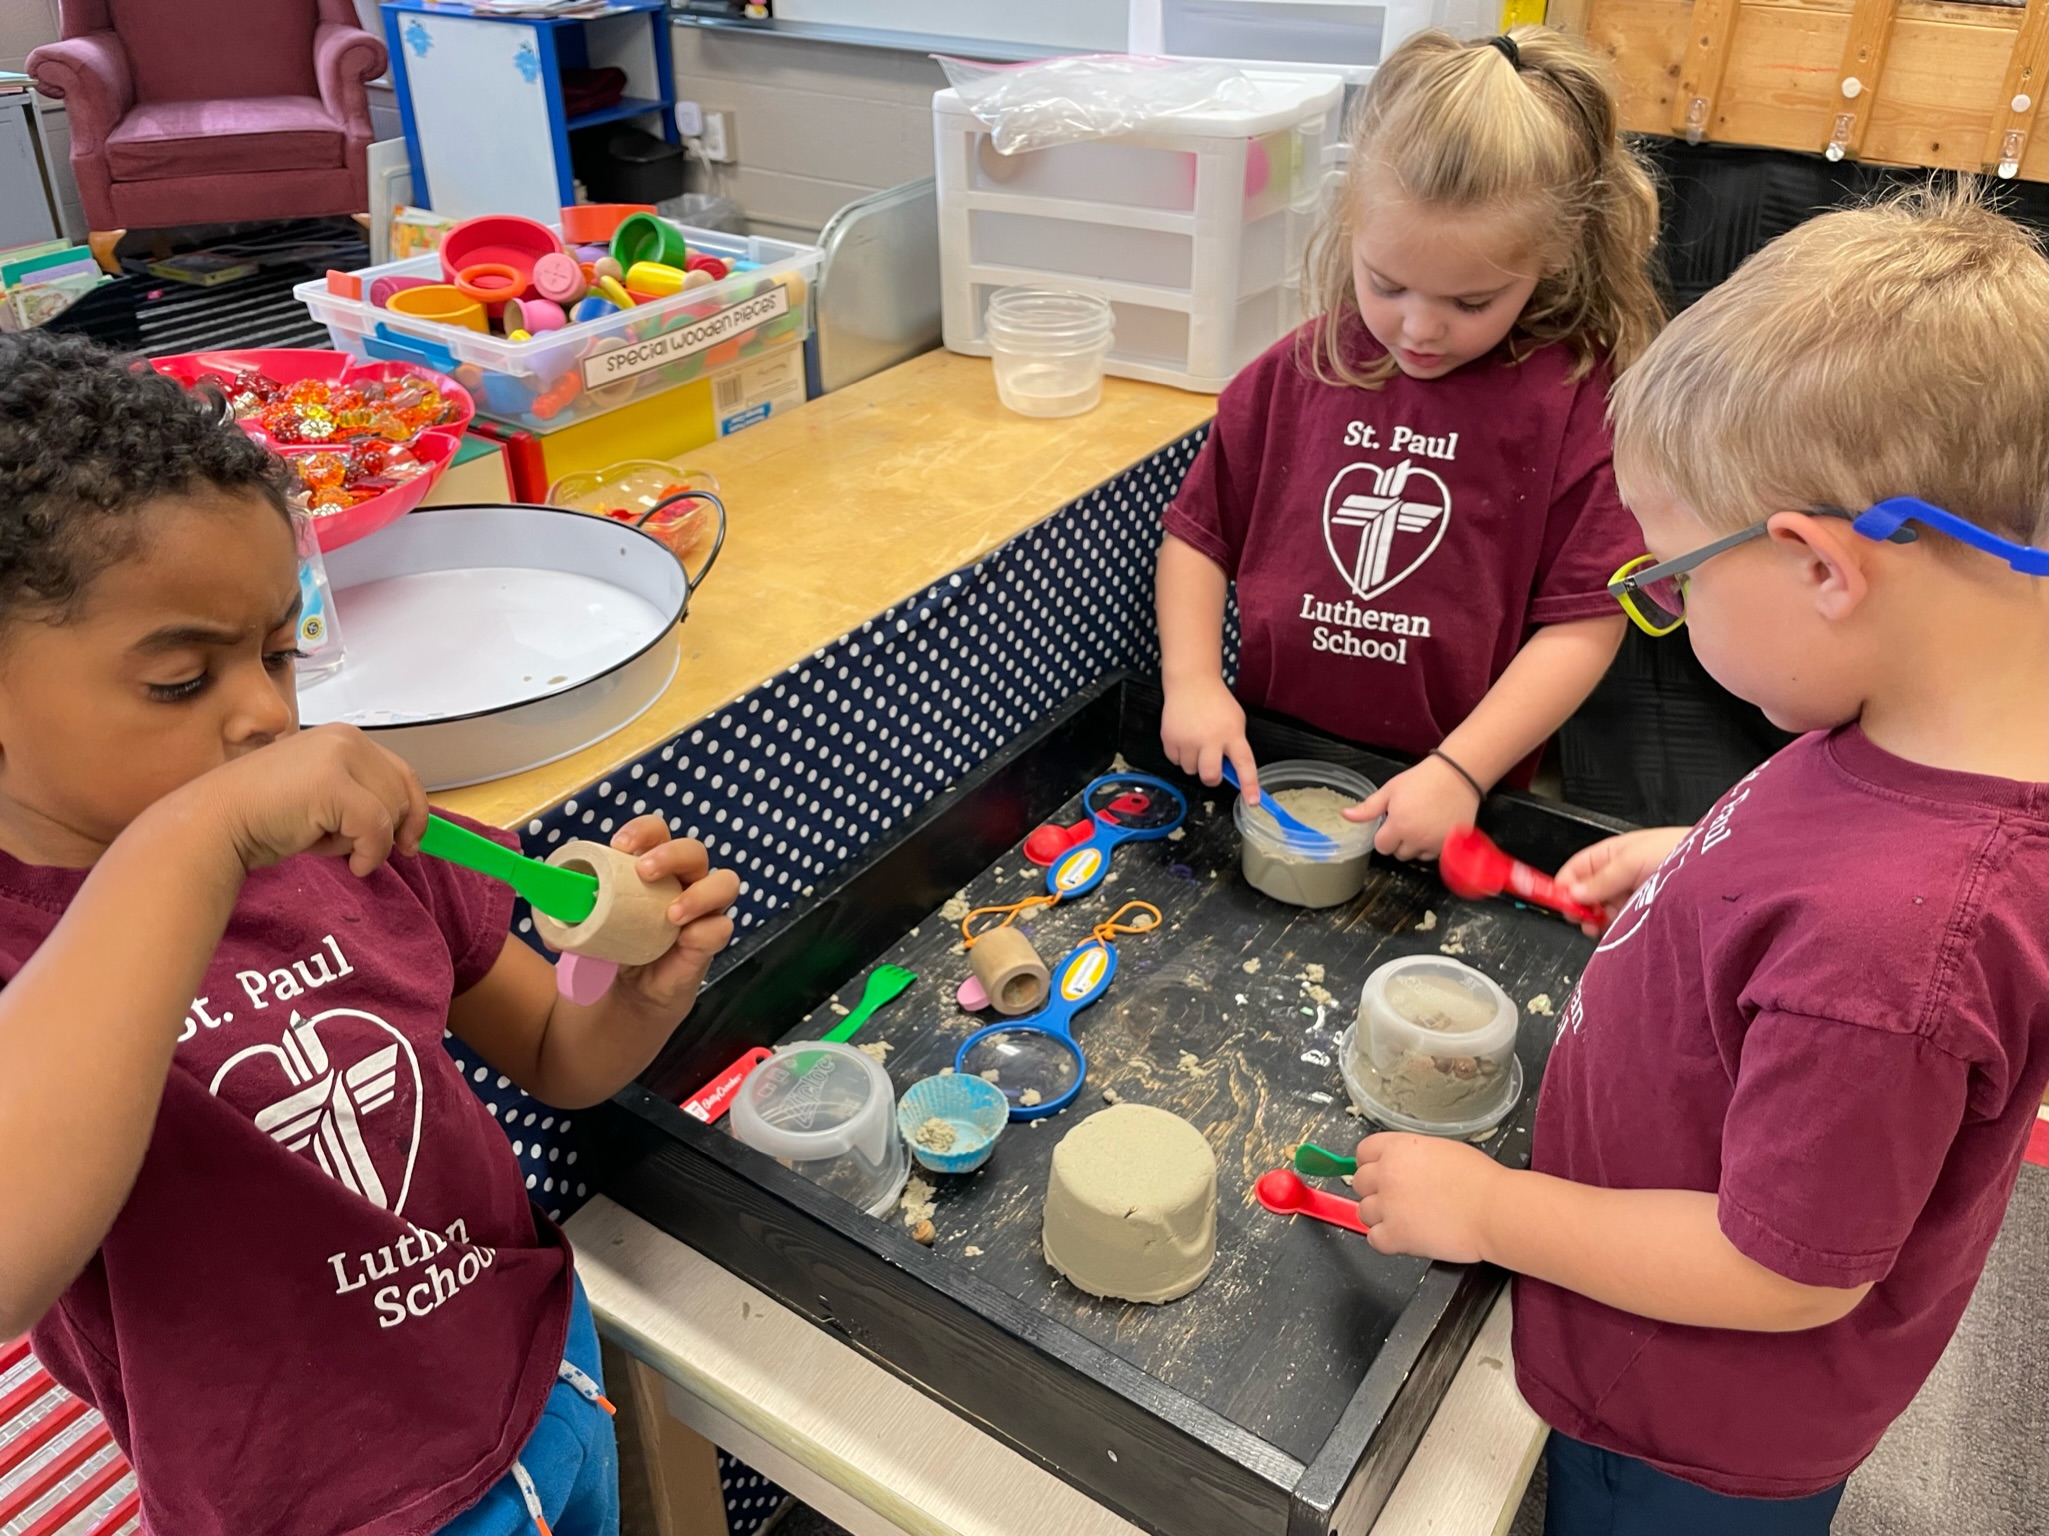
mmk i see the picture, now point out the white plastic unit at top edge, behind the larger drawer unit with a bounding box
[1129,0,1502,84]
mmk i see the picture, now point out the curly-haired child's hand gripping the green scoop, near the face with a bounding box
[184,725,426,877]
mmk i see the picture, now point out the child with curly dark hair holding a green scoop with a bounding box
[0,334,738,1536]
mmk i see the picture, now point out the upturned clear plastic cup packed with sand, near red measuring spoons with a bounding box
[1338,954,1522,1137]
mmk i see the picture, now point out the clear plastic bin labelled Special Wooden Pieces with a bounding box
[293,229,824,432]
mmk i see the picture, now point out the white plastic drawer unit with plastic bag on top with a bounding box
[932,72,1344,393]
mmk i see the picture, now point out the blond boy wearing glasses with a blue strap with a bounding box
[1354,193,2049,1536]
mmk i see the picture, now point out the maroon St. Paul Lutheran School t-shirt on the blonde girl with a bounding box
[1166,322,1643,782]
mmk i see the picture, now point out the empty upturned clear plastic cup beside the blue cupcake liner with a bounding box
[731,1040,897,1163]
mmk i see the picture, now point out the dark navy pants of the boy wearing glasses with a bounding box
[1543,1430,1842,1536]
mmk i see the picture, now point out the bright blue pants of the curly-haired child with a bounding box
[441,1280,619,1536]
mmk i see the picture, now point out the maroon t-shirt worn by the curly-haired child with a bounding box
[0,823,572,1536]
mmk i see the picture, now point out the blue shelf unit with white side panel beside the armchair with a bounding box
[379,0,676,223]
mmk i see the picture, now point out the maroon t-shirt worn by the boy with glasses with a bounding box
[1514,725,2049,1497]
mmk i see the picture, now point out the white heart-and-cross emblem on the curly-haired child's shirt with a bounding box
[209,1008,420,1214]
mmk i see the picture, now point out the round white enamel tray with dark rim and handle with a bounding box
[299,506,725,791]
